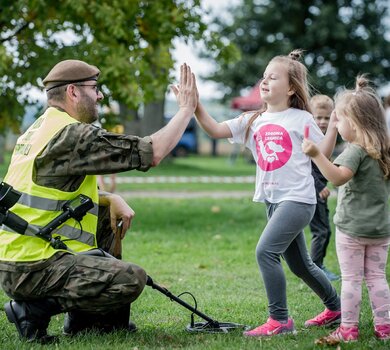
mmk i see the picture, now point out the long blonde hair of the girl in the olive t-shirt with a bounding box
[335,75,390,179]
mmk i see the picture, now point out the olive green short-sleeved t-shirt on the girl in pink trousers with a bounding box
[333,144,390,238]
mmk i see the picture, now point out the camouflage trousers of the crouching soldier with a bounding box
[0,204,146,314]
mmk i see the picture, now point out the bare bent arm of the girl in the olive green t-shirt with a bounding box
[302,139,354,186]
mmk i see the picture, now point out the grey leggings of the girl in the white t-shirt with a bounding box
[256,201,340,321]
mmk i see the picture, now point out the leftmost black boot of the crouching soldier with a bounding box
[4,298,61,344]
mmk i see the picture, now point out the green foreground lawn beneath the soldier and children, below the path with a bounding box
[0,198,390,350]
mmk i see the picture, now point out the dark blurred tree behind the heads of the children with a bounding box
[206,0,390,98]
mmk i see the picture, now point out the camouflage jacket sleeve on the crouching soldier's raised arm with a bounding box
[33,123,153,191]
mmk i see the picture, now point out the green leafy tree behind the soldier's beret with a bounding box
[0,0,219,132]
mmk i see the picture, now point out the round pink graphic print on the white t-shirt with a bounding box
[253,124,292,171]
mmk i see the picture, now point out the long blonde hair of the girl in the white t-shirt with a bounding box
[245,49,311,140]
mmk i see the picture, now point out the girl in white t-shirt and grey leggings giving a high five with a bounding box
[195,50,340,337]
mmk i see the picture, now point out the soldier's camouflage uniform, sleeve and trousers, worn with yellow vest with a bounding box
[0,116,153,314]
